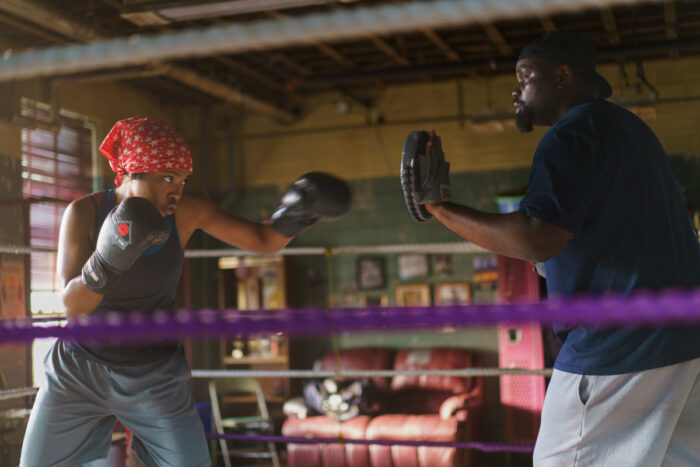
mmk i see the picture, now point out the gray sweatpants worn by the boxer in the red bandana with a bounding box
[20,341,211,467]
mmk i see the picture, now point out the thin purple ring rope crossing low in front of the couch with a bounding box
[207,433,535,452]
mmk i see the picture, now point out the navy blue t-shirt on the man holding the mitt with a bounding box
[520,100,700,375]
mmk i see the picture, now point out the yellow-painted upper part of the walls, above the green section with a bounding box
[0,58,700,192]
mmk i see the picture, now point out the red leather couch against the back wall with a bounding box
[282,348,483,467]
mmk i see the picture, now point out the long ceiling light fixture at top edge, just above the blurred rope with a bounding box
[121,0,335,26]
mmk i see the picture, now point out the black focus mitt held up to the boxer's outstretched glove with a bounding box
[401,131,452,222]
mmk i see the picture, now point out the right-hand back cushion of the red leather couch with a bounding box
[391,348,474,394]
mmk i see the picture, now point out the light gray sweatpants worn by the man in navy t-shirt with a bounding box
[534,359,700,467]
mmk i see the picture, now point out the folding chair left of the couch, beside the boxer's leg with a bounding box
[209,378,280,467]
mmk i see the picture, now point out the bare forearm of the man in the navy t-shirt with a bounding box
[426,203,570,261]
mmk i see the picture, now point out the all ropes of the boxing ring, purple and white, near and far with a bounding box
[0,0,688,462]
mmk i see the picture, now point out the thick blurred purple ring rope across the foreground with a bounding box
[0,289,700,342]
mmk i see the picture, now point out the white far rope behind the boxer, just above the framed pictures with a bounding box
[0,242,488,258]
